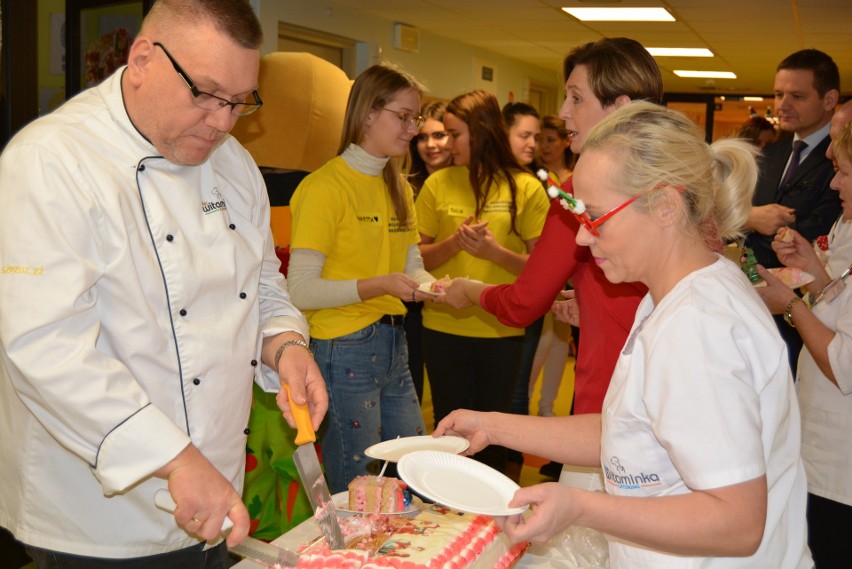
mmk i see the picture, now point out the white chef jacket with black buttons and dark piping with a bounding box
[0,69,308,558]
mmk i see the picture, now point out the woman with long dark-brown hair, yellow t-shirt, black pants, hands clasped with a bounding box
[417,90,548,471]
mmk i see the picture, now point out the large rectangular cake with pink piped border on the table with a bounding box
[298,505,528,569]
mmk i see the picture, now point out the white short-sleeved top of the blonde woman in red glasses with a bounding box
[601,257,813,569]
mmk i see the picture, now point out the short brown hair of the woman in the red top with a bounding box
[563,38,663,107]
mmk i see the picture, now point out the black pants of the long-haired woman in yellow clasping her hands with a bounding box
[423,328,524,472]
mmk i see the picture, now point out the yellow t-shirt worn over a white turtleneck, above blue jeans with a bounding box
[290,156,420,340]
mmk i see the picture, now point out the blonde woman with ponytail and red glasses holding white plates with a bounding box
[435,102,813,569]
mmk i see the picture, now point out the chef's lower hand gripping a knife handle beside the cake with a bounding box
[154,444,249,547]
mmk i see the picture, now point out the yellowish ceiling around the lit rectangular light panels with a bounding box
[329,0,852,94]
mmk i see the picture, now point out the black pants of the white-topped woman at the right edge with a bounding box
[808,494,852,569]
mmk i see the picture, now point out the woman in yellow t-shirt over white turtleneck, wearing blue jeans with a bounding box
[288,65,435,492]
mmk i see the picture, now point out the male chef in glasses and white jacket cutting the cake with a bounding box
[0,0,327,569]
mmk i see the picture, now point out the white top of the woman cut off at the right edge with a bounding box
[797,214,852,506]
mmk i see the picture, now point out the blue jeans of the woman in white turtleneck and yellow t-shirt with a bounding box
[311,322,426,493]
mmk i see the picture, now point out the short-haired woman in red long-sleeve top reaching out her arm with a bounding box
[446,38,663,414]
